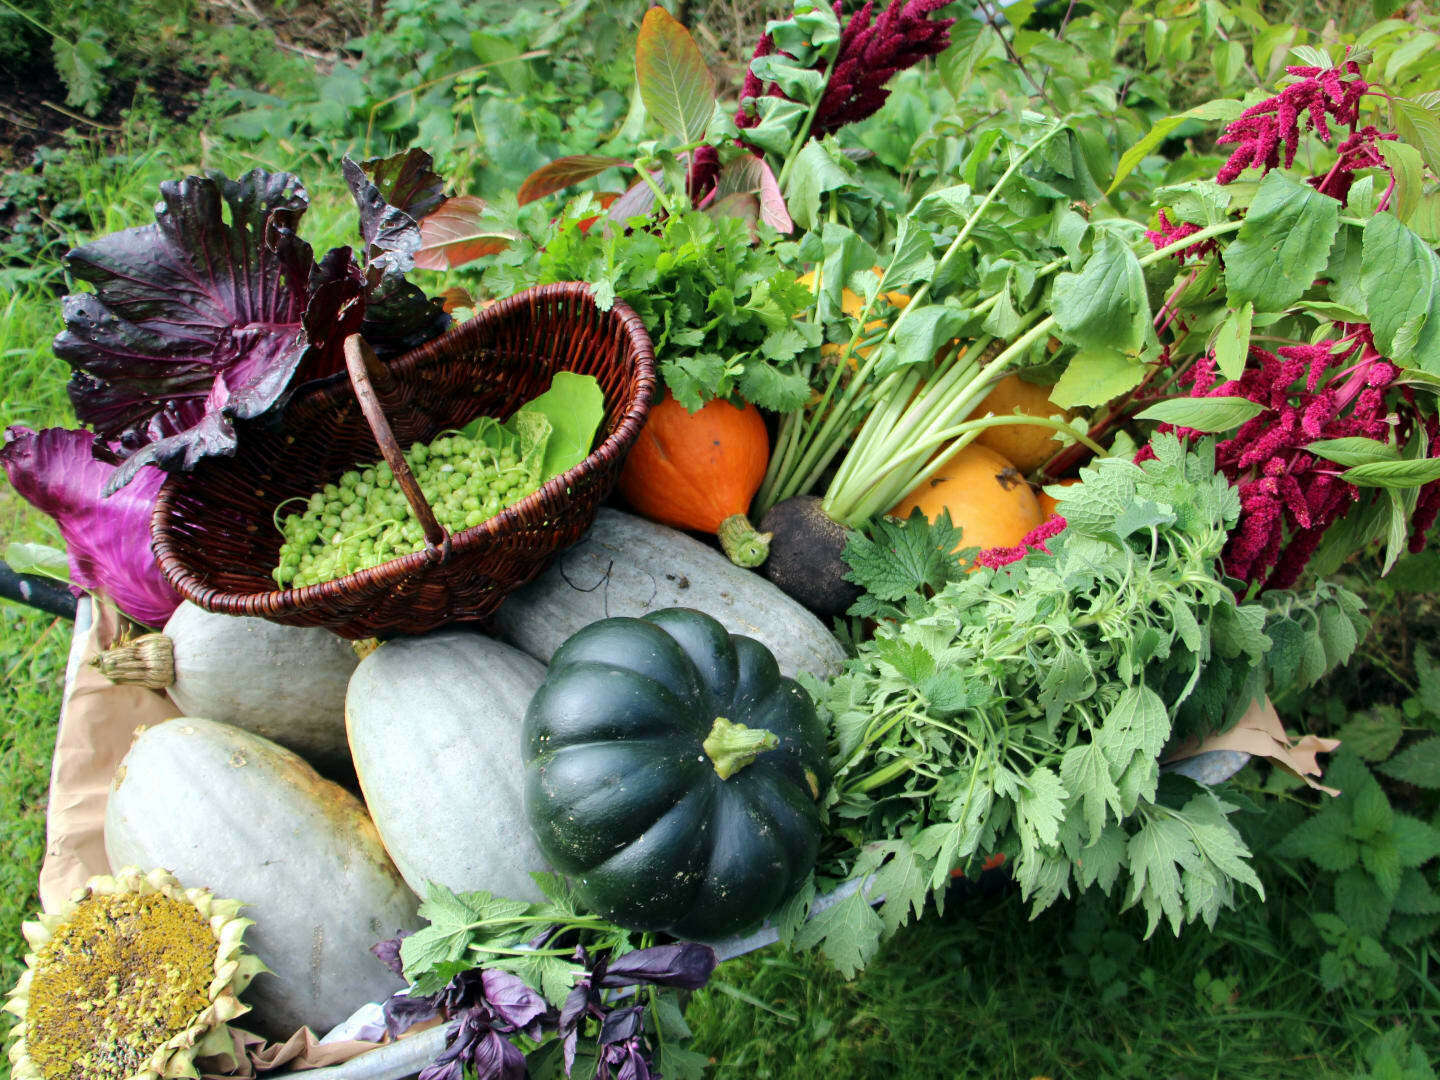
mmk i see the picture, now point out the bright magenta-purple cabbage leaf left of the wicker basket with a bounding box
[0,426,180,626]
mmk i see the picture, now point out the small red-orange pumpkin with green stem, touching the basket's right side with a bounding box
[619,390,770,566]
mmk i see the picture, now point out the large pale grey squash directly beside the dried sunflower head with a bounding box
[105,717,422,1037]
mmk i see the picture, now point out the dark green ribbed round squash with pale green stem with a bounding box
[524,608,829,940]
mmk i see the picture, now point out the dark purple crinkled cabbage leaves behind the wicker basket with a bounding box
[55,150,449,491]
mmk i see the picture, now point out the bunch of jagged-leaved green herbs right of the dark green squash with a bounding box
[798,436,1364,969]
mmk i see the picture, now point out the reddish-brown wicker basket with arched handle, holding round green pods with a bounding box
[151,282,655,638]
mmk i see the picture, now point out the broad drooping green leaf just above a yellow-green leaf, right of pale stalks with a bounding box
[1051,232,1152,354]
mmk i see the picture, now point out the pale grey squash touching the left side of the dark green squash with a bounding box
[346,628,547,900]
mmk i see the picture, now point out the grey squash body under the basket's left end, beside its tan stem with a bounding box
[164,602,360,779]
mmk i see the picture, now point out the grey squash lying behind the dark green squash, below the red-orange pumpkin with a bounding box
[491,507,845,677]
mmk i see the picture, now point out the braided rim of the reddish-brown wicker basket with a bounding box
[150,281,657,615]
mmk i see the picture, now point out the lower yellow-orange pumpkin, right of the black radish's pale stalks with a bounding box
[890,442,1045,549]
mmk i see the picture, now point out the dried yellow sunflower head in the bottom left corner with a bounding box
[4,868,265,1080]
